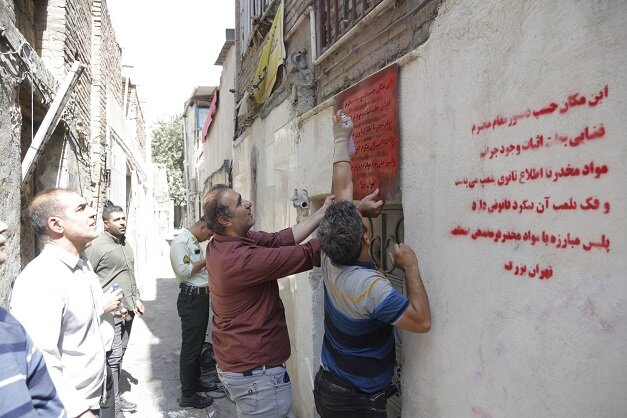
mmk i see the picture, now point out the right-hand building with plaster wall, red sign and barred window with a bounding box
[226,0,627,417]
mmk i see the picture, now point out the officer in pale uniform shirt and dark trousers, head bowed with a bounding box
[170,220,216,409]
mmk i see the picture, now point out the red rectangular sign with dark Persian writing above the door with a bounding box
[335,64,399,200]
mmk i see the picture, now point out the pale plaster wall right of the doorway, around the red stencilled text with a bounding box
[400,0,627,418]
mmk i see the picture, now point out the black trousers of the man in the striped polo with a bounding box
[314,367,387,418]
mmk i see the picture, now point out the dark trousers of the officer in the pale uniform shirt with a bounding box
[176,292,209,396]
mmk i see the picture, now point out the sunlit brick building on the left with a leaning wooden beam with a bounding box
[0,0,161,305]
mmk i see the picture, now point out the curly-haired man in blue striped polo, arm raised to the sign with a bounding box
[314,112,431,418]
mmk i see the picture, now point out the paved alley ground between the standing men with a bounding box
[120,245,236,418]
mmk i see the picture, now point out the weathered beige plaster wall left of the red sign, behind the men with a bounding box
[233,102,330,417]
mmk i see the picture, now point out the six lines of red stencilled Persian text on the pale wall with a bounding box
[450,85,612,280]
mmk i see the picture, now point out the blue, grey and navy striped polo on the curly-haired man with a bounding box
[321,254,409,393]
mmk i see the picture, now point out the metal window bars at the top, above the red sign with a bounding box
[316,0,382,52]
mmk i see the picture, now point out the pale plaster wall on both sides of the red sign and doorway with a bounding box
[234,0,627,418]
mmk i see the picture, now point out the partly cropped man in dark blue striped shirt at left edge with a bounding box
[0,217,67,417]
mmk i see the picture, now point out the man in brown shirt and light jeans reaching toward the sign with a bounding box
[203,185,334,418]
